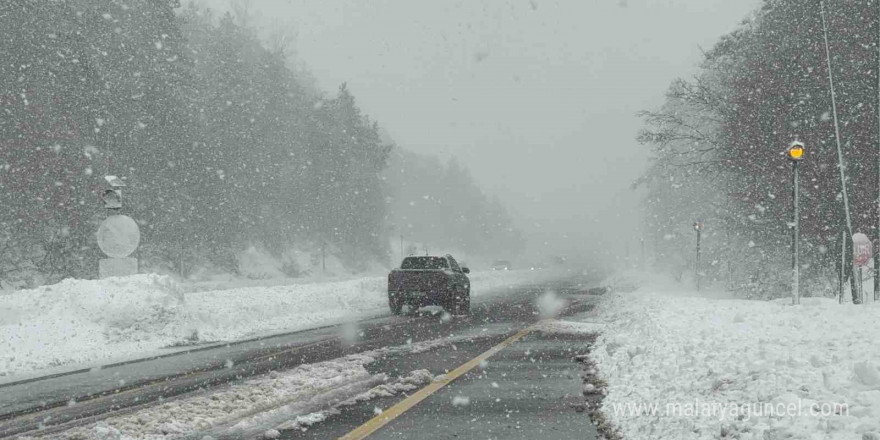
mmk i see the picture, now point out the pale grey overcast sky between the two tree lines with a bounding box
[198,0,760,262]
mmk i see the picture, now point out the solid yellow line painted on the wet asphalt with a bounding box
[339,325,535,440]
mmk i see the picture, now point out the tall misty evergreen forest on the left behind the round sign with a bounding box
[0,0,524,288]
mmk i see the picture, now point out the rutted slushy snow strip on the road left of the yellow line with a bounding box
[42,338,444,440]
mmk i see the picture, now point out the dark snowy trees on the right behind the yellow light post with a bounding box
[635,0,880,297]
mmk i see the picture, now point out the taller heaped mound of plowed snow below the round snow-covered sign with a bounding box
[0,275,190,379]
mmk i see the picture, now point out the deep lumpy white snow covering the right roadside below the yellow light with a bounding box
[588,277,880,440]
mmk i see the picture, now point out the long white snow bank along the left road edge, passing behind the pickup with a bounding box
[0,271,547,383]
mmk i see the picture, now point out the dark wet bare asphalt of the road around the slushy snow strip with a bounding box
[0,276,596,439]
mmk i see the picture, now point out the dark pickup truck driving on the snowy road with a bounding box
[388,255,471,315]
